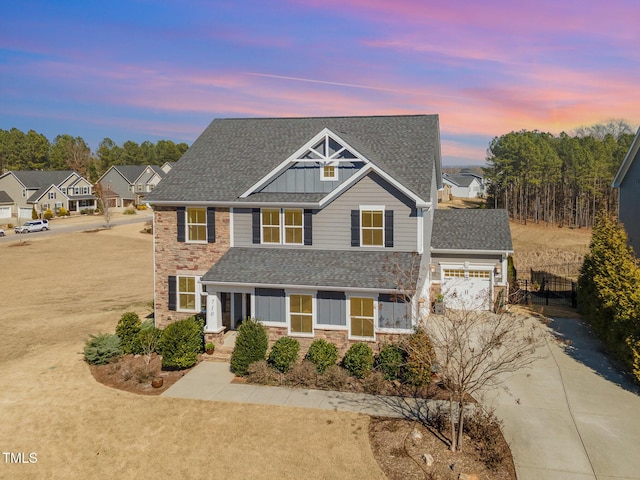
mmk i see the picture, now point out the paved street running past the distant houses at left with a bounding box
[0,211,153,242]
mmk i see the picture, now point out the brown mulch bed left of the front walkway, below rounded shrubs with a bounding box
[89,353,193,395]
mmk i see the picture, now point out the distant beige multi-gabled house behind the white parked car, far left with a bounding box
[0,170,96,218]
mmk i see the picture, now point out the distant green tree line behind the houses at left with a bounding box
[0,128,189,182]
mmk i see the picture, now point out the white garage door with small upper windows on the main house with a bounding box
[442,268,491,310]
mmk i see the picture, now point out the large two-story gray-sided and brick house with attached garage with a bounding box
[147,115,511,348]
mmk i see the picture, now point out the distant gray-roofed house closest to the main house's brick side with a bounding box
[96,162,166,207]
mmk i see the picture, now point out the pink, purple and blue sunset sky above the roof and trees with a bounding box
[0,0,640,165]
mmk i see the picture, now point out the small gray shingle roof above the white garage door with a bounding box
[431,209,513,251]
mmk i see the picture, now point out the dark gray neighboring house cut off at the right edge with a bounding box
[613,129,640,256]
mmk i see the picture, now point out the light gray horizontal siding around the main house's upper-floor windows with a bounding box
[233,173,418,252]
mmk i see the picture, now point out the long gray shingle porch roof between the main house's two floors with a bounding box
[202,247,419,290]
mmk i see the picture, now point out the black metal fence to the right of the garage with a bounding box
[511,271,578,308]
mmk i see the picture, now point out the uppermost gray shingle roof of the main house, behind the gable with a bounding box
[148,115,440,203]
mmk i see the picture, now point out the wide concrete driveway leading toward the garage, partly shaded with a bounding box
[485,318,640,480]
